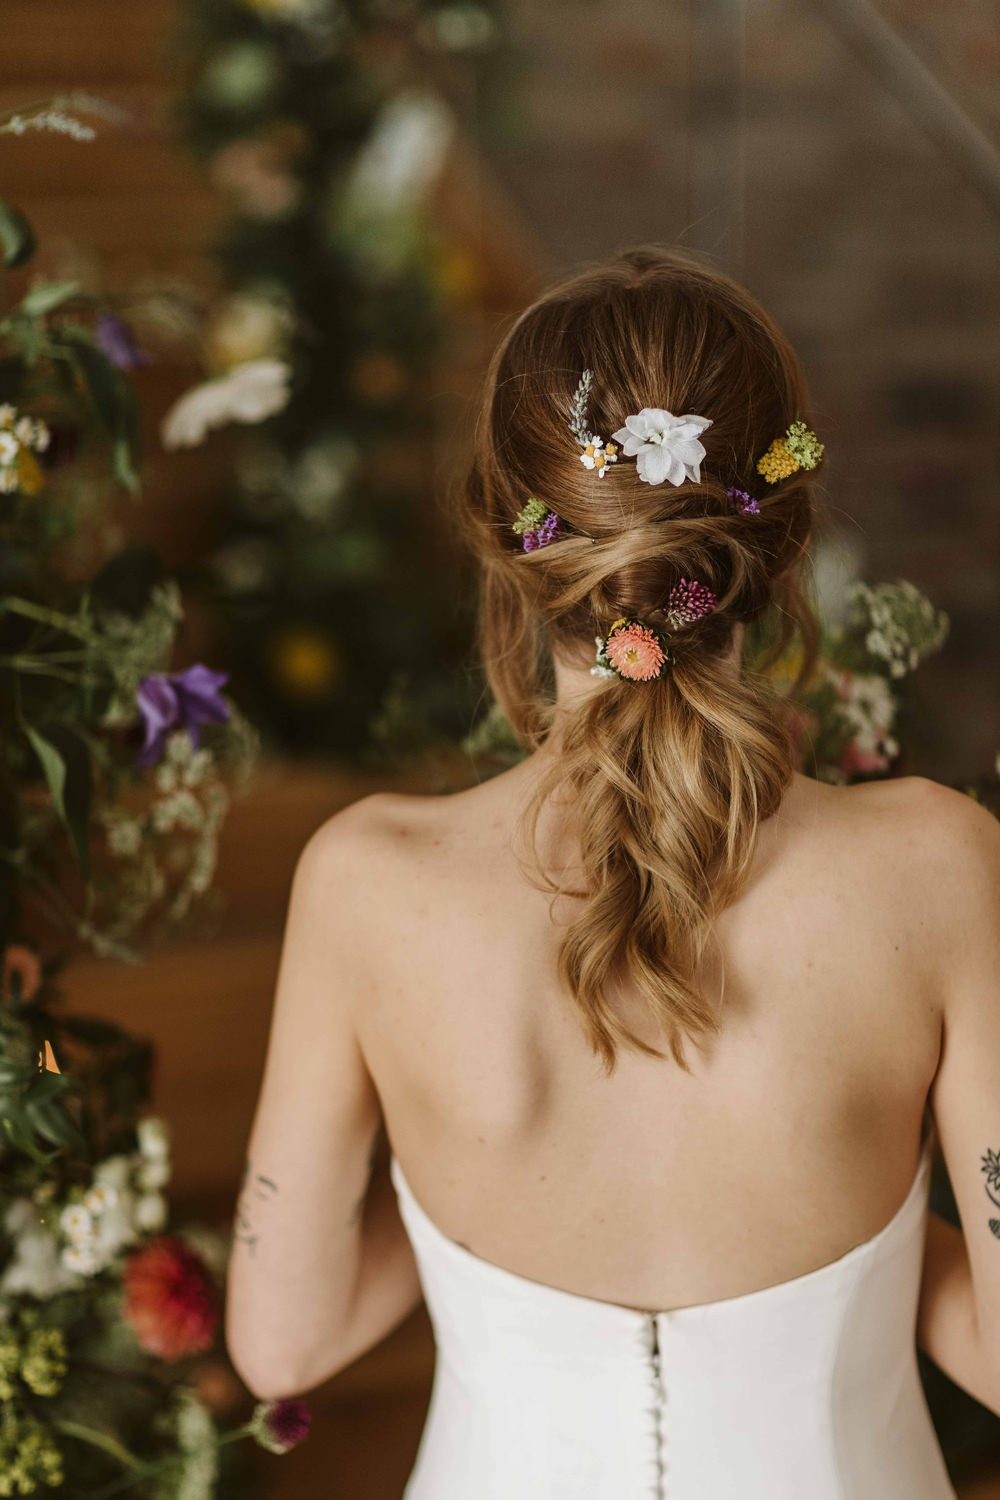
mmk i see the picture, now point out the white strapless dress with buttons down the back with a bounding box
[391,1139,955,1500]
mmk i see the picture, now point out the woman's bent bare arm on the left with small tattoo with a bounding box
[226,797,420,1400]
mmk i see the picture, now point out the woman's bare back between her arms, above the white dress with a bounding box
[346,758,951,1308]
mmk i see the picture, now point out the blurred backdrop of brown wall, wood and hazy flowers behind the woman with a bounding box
[0,0,1000,1500]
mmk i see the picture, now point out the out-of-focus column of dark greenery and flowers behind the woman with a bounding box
[173,0,500,753]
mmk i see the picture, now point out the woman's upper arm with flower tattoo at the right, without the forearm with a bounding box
[928,788,1000,1364]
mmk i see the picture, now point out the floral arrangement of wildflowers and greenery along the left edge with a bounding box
[0,96,309,1500]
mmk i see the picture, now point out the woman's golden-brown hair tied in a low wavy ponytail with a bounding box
[459,248,816,1073]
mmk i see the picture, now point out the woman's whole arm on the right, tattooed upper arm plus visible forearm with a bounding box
[918,788,1000,1415]
